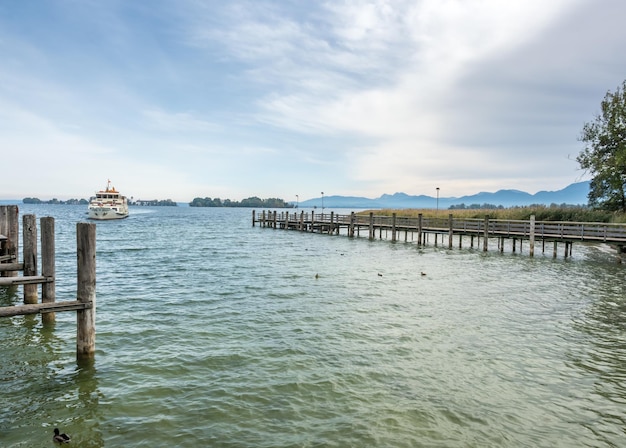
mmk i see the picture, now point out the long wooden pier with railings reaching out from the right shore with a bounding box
[252,210,626,262]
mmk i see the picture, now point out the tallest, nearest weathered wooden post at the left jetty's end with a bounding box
[76,222,96,360]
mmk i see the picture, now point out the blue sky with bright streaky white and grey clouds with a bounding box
[0,0,626,202]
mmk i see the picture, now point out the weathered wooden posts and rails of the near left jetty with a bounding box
[0,205,96,360]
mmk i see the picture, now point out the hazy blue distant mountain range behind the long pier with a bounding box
[299,181,589,209]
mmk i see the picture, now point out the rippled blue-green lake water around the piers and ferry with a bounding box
[0,205,626,448]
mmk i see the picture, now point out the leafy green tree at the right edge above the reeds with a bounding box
[576,81,626,212]
